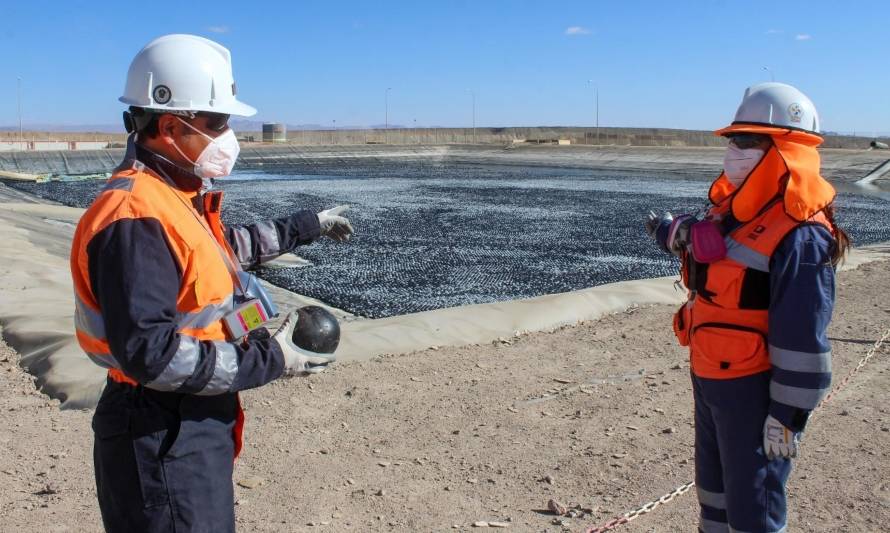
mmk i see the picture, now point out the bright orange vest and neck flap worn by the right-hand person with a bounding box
[674,128,835,379]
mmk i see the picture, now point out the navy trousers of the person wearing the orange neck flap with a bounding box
[692,372,791,533]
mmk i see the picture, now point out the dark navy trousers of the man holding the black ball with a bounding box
[93,380,238,533]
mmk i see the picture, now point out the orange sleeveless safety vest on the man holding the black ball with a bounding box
[71,161,244,455]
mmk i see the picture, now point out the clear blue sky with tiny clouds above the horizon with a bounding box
[0,0,890,132]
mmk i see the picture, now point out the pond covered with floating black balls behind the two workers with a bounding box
[14,160,890,318]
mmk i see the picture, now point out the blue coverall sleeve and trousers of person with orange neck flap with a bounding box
[692,225,835,533]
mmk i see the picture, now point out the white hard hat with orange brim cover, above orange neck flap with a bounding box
[716,82,819,135]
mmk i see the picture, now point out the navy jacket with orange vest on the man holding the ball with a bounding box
[71,144,319,454]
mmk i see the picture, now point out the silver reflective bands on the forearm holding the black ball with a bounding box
[145,333,238,395]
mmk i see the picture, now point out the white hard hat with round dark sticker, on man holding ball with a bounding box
[119,34,256,117]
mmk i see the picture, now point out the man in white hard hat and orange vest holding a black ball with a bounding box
[71,35,352,533]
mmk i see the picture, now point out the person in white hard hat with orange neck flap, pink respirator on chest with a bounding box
[647,83,849,533]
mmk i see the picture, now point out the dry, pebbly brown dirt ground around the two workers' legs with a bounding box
[0,255,890,532]
